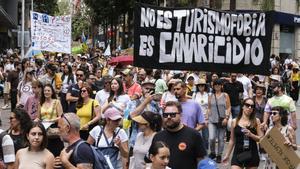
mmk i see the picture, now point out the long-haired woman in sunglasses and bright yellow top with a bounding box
[76,83,101,140]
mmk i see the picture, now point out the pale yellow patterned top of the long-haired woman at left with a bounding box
[41,99,59,120]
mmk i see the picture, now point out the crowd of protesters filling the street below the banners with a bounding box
[0,47,300,169]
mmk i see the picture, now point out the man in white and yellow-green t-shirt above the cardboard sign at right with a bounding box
[261,83,297,130]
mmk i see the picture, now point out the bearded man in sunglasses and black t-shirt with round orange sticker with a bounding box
[152,101,206,169]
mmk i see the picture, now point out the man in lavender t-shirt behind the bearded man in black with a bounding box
[174,81,205,131]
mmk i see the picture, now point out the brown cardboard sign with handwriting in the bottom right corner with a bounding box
[260,127,300,169]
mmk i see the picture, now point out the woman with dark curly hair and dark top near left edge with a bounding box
[8,108,32,152]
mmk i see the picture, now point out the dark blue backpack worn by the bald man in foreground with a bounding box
[73,140,112,169]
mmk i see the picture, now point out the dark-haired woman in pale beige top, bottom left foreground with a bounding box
[15,122,54,169]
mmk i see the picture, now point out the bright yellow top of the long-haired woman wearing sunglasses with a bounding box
[76,99,99,128]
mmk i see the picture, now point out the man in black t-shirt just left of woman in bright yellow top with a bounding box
[66,69,85,113]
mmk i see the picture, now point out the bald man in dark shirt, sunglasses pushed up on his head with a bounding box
[54,113,95,169]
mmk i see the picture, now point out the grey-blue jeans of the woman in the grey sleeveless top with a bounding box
[208,123,226,155]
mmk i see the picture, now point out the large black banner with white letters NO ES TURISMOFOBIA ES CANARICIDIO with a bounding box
[134,3,273,75]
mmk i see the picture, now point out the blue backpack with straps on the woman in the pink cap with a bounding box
[95,126,121,169]
